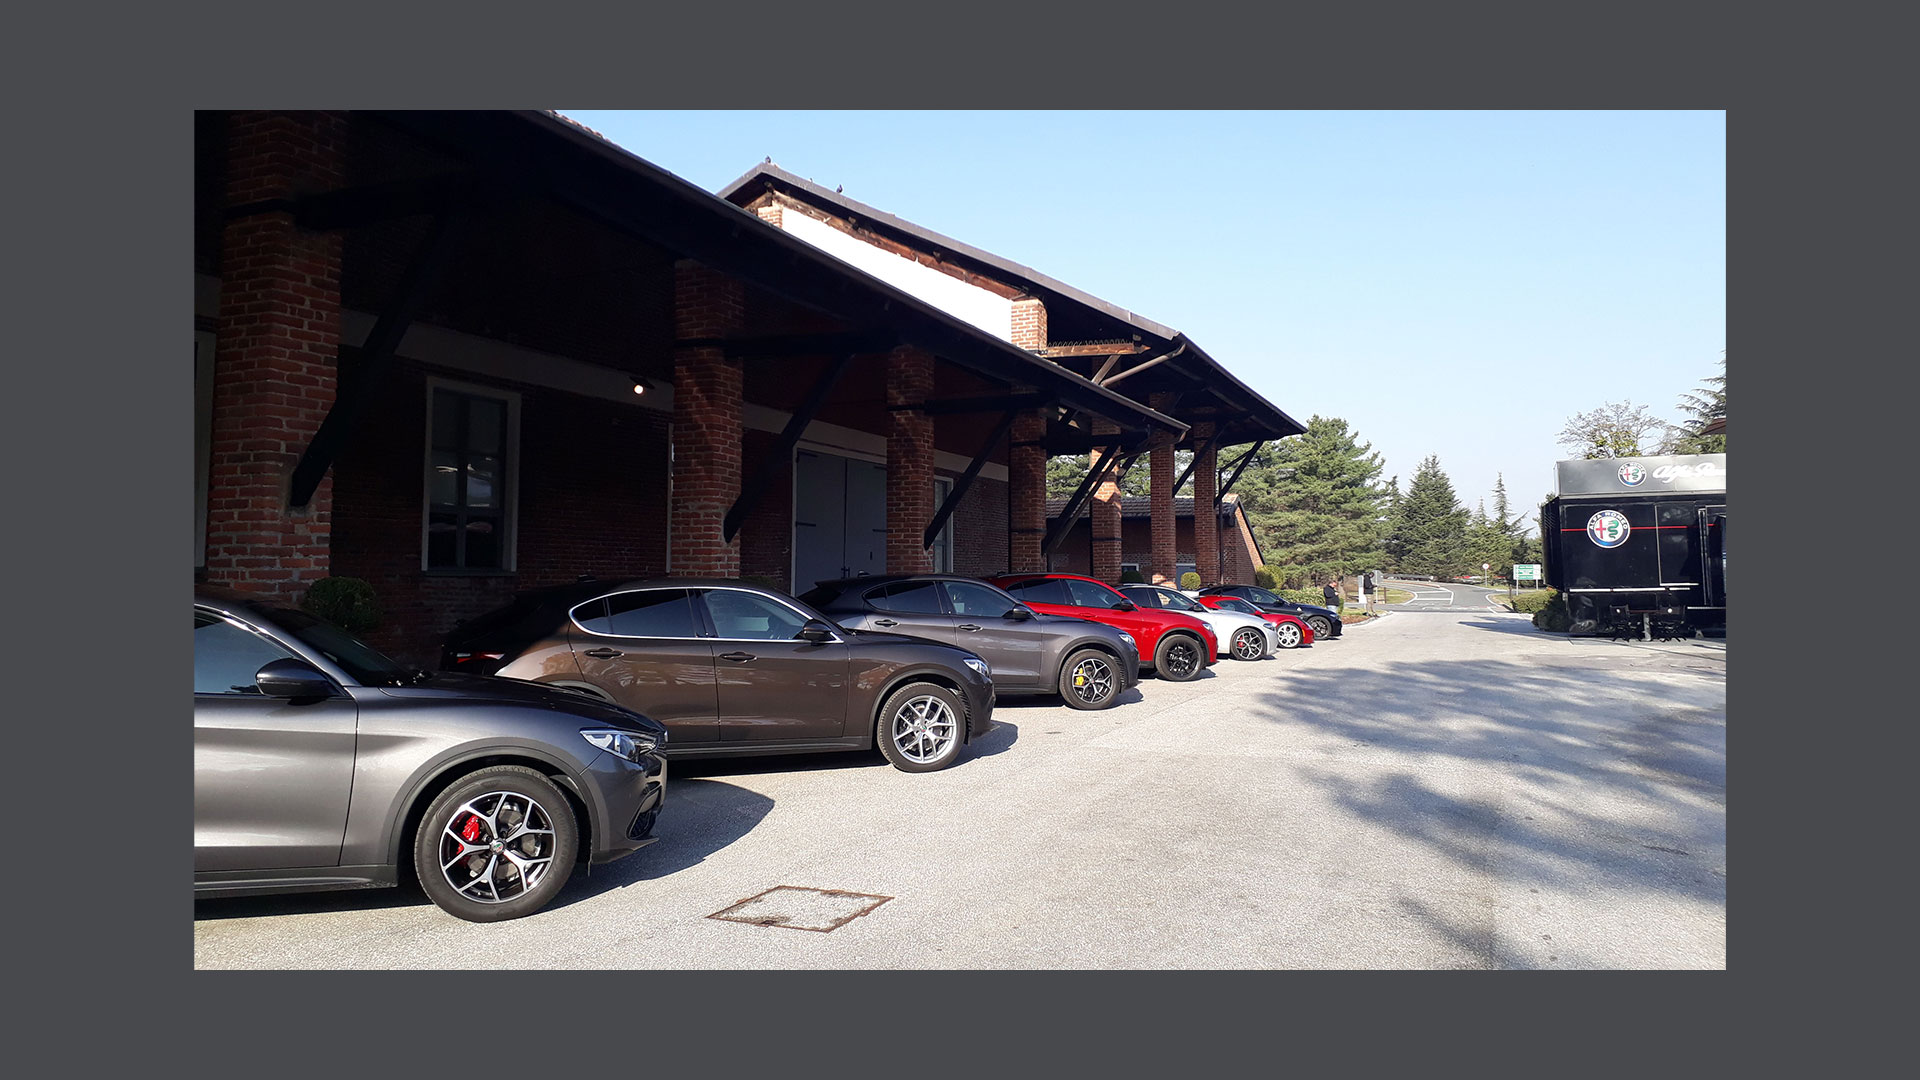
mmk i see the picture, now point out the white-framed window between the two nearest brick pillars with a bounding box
[420,379,520,571]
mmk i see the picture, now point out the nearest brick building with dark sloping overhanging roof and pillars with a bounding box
[194,111,1298,661]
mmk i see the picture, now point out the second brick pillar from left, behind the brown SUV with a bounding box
[666,259,745,577]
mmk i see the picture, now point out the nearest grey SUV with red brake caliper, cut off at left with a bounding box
[194,588,666,922]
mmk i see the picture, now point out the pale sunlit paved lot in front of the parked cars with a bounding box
[194,613,1726,969]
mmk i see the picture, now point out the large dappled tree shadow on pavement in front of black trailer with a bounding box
[1254,657,1726,907]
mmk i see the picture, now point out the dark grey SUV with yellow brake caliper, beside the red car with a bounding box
[801,575,1140,709]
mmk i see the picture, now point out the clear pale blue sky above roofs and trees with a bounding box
[563,110,1726,526]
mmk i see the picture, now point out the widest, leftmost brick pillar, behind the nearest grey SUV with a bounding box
[207,111,346,600]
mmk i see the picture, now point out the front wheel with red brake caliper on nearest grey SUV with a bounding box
[413,765,580,922]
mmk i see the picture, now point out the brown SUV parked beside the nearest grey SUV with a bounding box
[440,578,995,773]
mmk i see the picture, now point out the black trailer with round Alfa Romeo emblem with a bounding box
[1540,454,1726,638]
